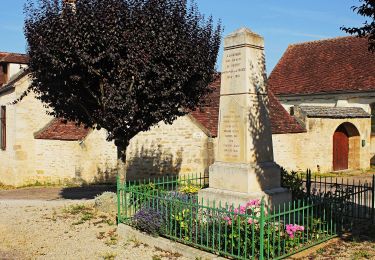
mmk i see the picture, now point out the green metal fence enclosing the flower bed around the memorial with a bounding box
[117,176,342,259]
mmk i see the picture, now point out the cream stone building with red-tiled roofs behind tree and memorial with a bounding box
[0,51,304,186]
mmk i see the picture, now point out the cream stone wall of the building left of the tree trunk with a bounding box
[0,77,117,186]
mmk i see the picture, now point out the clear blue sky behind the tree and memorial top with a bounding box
[0,0,364,73]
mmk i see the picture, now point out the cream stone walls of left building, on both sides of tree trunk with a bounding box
[0,74,216,186]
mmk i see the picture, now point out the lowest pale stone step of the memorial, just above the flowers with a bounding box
[198,188,292,208]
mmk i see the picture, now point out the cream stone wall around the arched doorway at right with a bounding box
[272,118,371,172]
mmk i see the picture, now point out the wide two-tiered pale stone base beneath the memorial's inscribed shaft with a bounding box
[198,162,292,207]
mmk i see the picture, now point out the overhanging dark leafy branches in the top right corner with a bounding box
[341,0,375,52]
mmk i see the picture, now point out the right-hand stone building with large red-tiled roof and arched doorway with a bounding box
[268,37,375,172]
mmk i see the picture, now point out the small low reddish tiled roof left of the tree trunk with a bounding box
[34,119,90,141]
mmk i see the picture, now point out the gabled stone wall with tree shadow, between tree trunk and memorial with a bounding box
[127,116,215,180]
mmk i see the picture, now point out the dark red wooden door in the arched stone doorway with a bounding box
[333,126,349,171]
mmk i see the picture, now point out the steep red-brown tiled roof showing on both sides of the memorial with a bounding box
[191,75,305,137]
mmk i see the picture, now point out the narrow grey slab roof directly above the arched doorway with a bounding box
[299,106,371,118]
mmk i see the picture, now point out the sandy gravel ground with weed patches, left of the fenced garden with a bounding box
[0,199,187,260]
